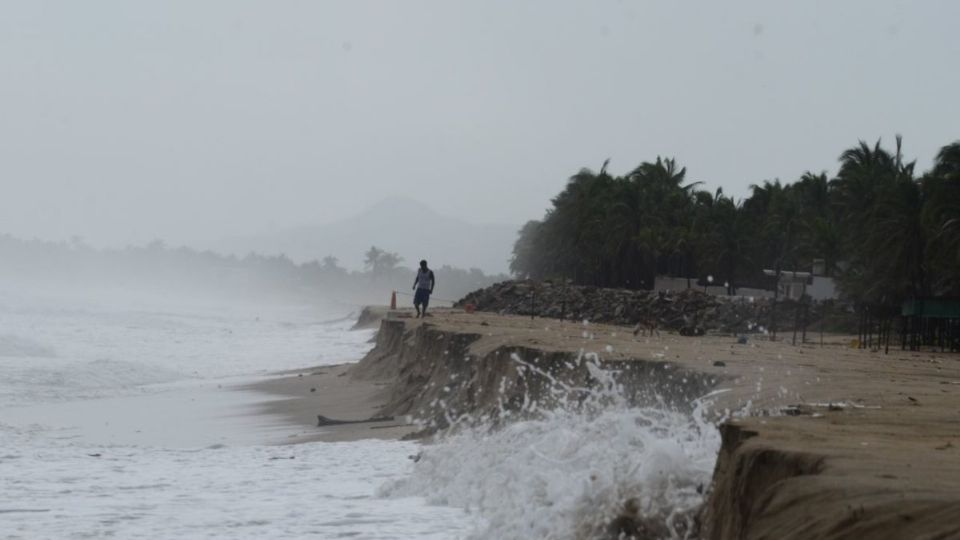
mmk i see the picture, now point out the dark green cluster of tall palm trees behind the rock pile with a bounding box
[510,136,960,307]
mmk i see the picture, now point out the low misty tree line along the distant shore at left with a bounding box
[0,234,507,304]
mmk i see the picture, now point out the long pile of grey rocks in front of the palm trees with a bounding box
[456,281,856,334]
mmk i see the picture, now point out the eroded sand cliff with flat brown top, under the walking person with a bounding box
[350,313,960,538]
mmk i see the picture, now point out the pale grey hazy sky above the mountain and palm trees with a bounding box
[0,0,960,249]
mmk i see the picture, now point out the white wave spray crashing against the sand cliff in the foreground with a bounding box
[382,356,720,539]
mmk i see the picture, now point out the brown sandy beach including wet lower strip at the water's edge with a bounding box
[266,310,960,538]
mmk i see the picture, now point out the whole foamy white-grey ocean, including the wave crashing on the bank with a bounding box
[0,291,719,539]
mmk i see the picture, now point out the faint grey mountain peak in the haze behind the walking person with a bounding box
[215,197,519,273]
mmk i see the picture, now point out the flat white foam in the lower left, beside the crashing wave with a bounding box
[0,426,470,539]
